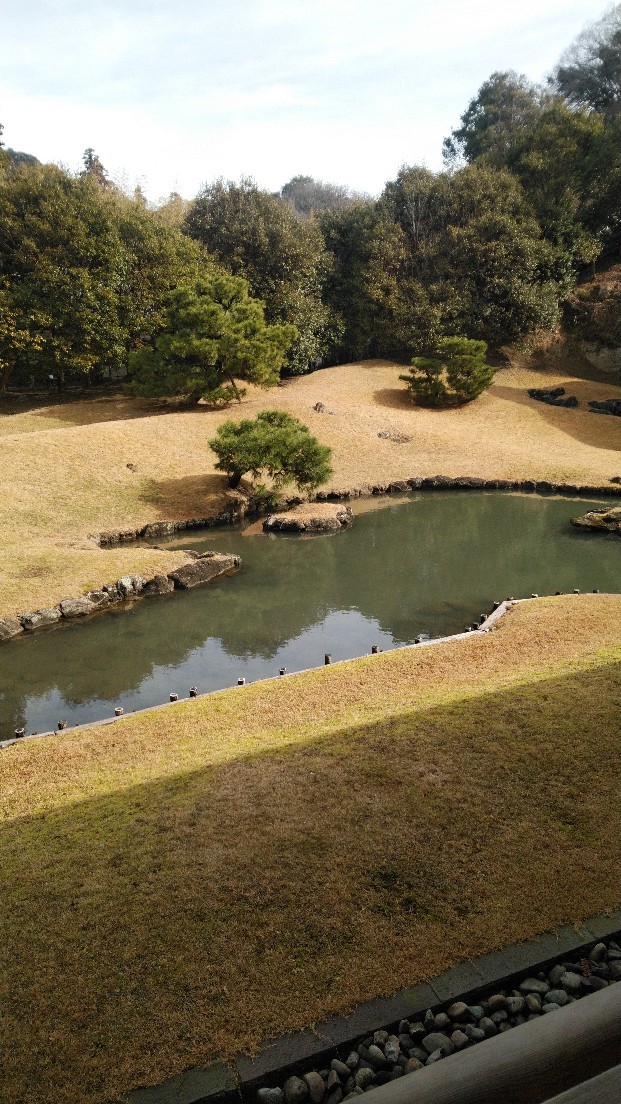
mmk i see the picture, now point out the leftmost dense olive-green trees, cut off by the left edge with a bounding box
[0,155,204,389]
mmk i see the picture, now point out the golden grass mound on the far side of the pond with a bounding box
[0,361,621,616]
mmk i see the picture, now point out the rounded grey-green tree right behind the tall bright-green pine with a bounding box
[185,180,343,374]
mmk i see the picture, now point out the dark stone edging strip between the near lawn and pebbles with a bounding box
[106,910,621,1104]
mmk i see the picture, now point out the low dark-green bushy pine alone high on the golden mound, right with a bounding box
[399,337,496,407]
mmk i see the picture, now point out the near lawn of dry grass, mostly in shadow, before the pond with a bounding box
[0,595,621,1104]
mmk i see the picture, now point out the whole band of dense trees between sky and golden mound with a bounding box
[0,4,621,394]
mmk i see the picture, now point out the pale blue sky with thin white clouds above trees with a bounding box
[0,0,610,201]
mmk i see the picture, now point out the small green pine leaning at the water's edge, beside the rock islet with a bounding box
[209,411,333,490]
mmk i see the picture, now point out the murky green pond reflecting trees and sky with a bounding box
[0,491,621,740]
